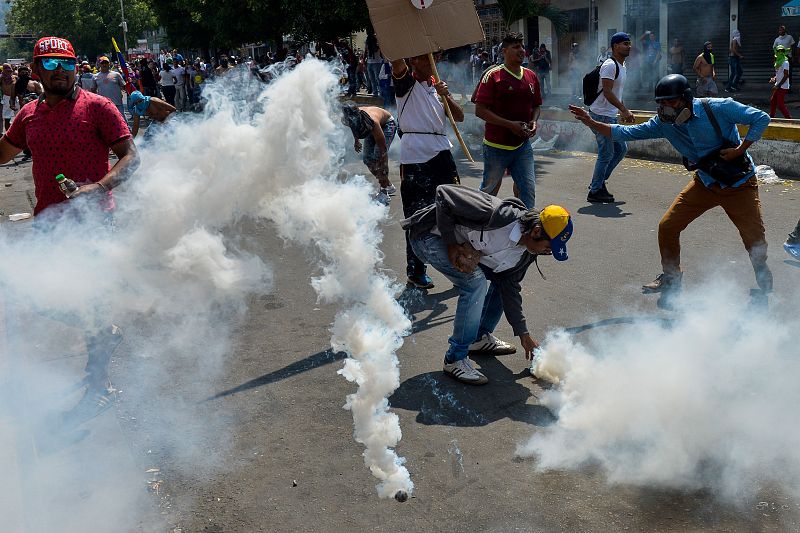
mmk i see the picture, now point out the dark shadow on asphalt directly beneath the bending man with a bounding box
[389,356,555,427]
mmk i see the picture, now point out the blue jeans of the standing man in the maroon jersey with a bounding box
[481,141,536,209]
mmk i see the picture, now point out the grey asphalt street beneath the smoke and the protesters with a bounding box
[0,147,800,532]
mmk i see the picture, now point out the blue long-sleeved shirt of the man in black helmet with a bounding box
[611,98,770,187]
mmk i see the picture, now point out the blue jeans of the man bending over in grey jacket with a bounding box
[411,233,503,363]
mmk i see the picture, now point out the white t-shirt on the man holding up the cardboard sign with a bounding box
[397,81,453,164]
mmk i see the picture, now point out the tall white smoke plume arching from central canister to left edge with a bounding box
[0,56,413,531]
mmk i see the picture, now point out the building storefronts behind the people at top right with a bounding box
[476,0,800,91]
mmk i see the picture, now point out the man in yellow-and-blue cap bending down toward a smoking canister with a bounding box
[403,185,572,385]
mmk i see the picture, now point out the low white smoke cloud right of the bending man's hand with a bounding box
[518,280,800,501]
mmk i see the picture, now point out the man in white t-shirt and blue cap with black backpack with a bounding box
[583,32,634,203]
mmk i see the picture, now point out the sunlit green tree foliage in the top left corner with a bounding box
[6,0,157,58]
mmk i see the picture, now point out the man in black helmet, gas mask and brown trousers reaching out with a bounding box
[570,74,772,301]
